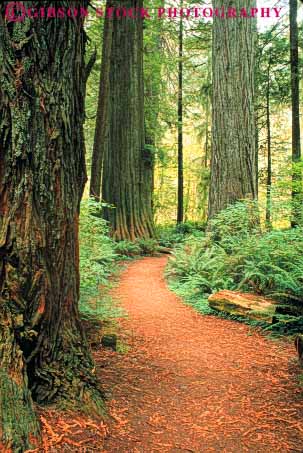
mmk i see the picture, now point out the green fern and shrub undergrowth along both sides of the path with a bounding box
[80,200,303,332]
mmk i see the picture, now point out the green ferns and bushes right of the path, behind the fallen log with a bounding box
[167,203,303,332]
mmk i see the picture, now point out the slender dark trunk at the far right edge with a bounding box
[289,0,302,227]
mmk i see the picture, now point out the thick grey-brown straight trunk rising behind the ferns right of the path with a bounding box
[208,0,257,218]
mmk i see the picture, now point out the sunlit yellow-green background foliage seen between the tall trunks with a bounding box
[85,1,302,227]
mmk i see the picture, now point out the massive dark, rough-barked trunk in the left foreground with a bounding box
[0,0,102,452]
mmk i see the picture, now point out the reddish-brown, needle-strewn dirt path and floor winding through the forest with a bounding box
[41,257,303,453]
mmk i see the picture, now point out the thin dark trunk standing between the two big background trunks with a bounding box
[177,5,184,223]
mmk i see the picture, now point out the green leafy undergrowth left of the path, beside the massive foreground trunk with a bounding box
[79,199,159,321]
